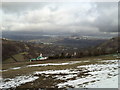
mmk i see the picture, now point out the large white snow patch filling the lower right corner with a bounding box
[58,60,118,88]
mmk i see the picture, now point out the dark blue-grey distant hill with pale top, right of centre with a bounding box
[55,37,107,48]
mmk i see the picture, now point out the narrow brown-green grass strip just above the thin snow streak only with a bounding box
[2,53,116,69]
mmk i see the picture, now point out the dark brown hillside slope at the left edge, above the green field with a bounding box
[2,39,29,62]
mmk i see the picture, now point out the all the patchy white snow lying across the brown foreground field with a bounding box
[0,60,118,88]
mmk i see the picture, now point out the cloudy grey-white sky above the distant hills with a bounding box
[0,2,118,36]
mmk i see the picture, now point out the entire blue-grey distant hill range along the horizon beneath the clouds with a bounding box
[3,32,107,48]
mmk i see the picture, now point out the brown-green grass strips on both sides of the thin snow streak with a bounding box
[2,56,116,78]
